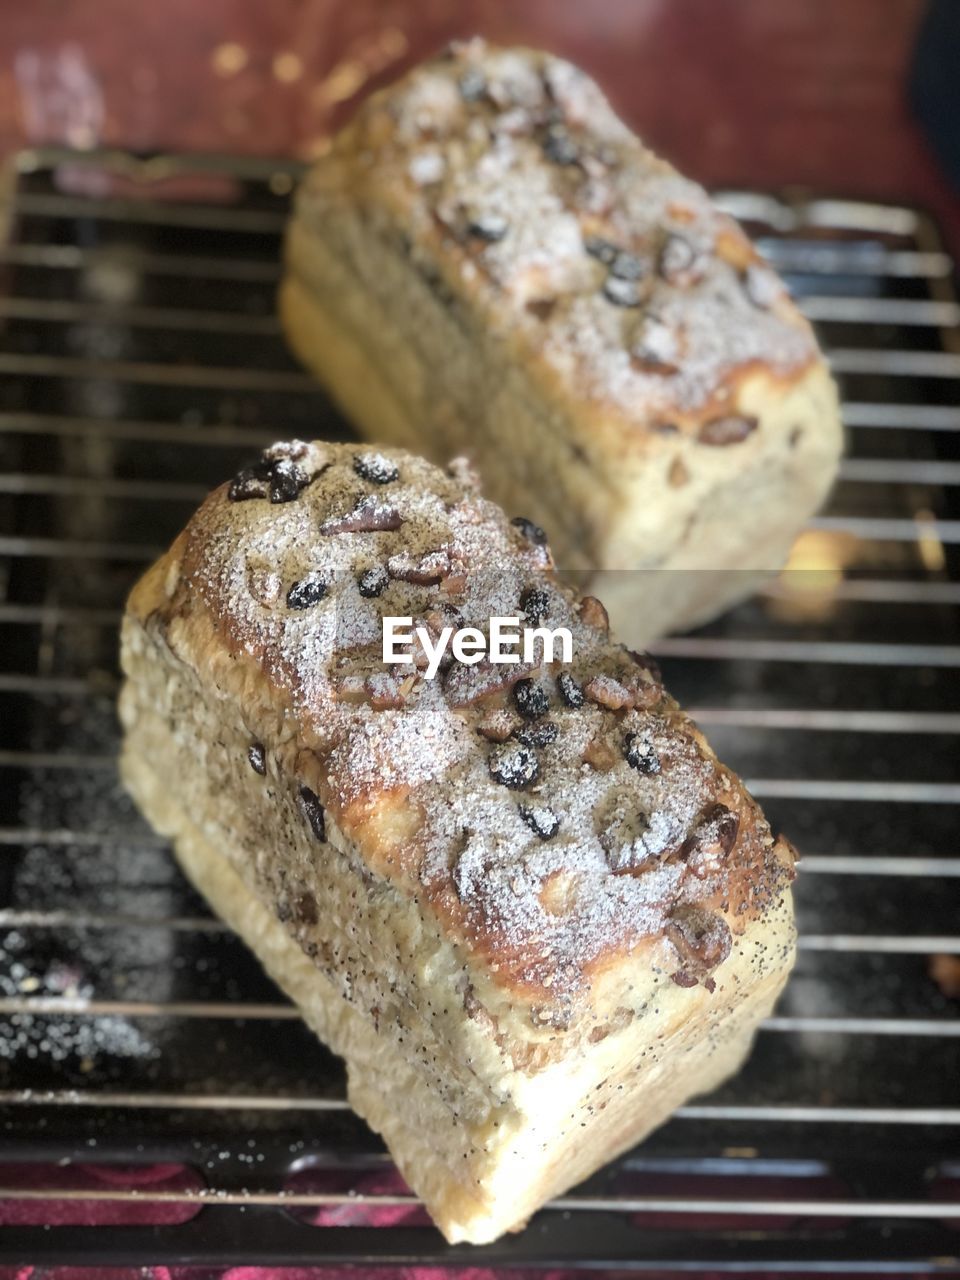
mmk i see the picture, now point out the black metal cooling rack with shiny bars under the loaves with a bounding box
[0,152,960,1274]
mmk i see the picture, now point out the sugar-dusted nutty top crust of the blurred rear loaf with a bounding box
[308,40,817,425]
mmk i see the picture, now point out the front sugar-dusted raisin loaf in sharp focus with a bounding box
[122,442,794,1240]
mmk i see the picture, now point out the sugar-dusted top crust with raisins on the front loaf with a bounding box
[169,445,783,993]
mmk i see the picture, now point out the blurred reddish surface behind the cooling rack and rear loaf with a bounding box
[0,0,960,247]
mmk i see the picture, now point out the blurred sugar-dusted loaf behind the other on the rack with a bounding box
[280,41,841,644]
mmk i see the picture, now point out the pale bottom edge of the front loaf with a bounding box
[122,745,786,1244]
